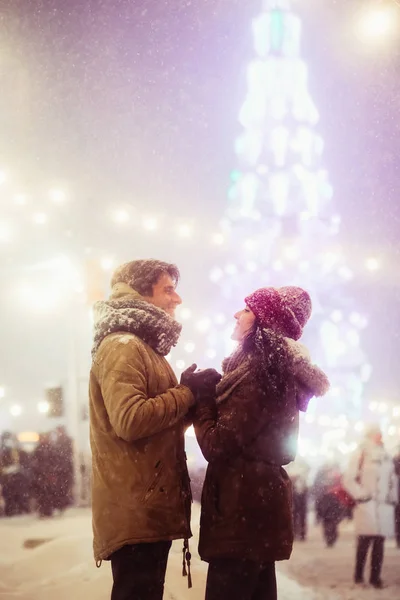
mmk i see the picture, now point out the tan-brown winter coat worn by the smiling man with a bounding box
[89,333,194,561]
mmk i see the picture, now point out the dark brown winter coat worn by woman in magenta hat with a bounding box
[195,372,298,563]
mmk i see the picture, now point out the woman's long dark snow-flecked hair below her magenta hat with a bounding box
[242,323,290,399]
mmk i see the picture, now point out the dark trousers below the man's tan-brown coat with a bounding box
[111,542,171,600]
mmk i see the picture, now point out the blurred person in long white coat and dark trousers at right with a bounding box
[343,425,398,589]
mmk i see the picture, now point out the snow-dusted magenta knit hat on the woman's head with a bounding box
[245,286,312,340]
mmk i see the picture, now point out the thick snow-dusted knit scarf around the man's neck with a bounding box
[92,284,182,358]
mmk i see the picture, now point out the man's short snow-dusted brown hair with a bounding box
[111,259,180,296]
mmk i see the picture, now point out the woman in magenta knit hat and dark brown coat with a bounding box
[194,288,329,600]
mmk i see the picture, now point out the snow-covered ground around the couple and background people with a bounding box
[0,507,400,600]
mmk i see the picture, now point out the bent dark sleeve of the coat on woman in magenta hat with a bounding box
[193,378,273,462]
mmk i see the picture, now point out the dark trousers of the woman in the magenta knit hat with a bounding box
[205,558,278,600]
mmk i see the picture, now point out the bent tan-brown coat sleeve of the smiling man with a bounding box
[99,342,194,442]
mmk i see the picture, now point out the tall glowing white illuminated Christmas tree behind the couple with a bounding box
[178,0,370,454]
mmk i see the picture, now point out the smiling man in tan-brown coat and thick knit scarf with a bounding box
[89,260,219,600]
